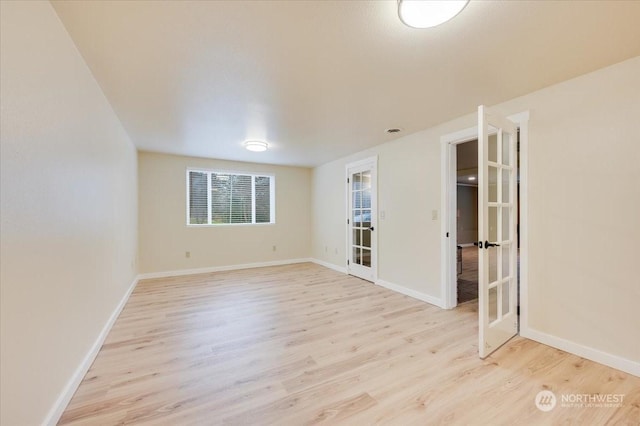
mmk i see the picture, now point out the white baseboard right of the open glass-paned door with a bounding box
[520,327,640,377]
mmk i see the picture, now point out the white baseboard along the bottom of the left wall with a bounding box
[42,277,138,426]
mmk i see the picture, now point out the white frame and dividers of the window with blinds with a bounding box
[185,167,276,228]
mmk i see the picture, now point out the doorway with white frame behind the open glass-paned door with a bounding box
[441,111,529,340]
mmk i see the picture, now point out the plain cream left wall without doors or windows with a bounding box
[0,1,137,425]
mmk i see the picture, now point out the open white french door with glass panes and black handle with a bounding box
[478,106,518,358]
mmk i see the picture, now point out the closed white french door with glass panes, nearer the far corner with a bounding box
[347,158,378,282]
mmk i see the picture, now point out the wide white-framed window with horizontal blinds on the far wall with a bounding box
[187,170,275,225]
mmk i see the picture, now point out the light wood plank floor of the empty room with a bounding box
[60,264,640,425]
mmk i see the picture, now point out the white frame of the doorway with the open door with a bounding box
[440,111,529,330]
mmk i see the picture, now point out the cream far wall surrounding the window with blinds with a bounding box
[138,152,311,273]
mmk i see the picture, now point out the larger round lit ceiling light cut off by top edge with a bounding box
[398,0,469,28]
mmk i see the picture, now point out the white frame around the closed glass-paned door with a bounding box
[344,155,379,284]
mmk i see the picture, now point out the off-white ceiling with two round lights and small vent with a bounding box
[52,0,640,166]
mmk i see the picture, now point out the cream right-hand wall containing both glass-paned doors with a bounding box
[312,57,640,371]
